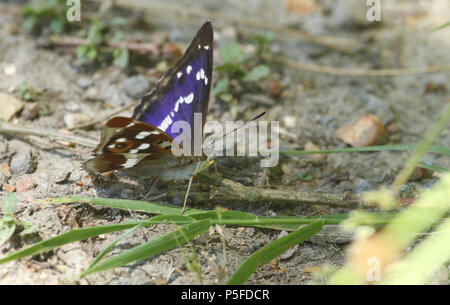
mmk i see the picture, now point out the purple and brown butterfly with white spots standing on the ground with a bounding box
[83,21,213,212]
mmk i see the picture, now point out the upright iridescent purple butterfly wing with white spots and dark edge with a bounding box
[132,21,213,142]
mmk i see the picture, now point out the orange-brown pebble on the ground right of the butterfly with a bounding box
[335,114,388,147]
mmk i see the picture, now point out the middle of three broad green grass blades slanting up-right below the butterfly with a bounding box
[81,219,211,277]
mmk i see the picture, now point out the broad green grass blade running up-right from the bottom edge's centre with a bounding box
[227,220,323,285]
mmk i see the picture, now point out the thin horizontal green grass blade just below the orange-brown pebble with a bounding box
[280,145,450,156]
